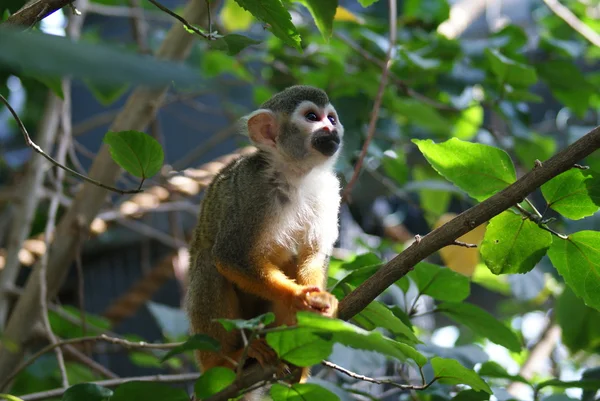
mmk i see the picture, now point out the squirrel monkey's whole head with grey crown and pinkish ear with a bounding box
[243,85,344,166]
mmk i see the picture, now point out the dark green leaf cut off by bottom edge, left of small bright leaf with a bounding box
[110,381,190,401]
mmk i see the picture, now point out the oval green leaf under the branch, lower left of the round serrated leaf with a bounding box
[407,262,471,302]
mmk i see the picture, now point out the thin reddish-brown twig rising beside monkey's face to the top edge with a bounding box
[343,0,398,201]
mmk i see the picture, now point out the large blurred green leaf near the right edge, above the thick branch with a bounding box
[536,60,595,118]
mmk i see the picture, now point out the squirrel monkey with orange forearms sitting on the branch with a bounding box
[185,86,344,381]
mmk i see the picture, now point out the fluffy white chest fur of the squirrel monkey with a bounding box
[266,169,340,254]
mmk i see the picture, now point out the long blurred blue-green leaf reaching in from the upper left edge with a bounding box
[0,26,200,87]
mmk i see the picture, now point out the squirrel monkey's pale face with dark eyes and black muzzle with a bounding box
[279,101,344,160]
